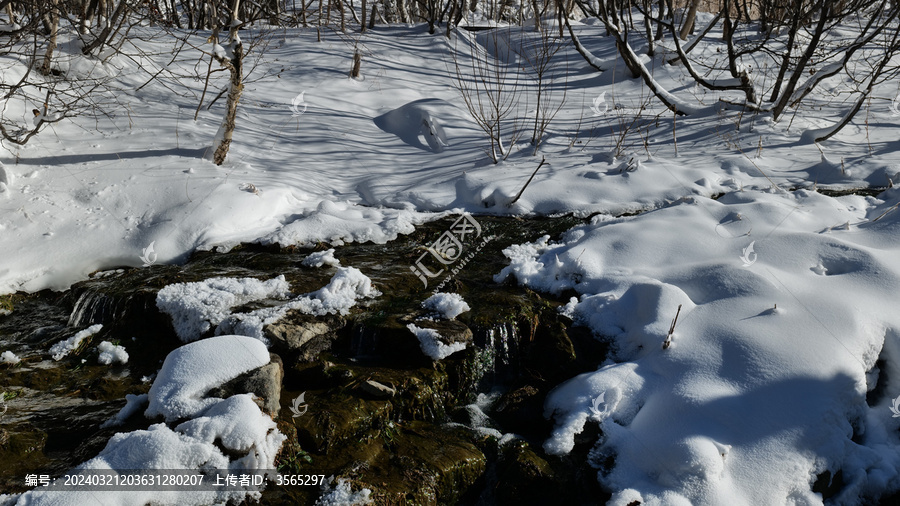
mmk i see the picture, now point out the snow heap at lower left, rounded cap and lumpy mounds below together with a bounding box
[12,336,285,506]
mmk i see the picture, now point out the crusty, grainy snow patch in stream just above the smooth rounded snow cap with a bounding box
[156,275,290,343]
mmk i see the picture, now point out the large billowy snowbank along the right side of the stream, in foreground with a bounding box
[497,190,900,505]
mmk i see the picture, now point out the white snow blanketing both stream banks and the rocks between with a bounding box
[0,10,900,505]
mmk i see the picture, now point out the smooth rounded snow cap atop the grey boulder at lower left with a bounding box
[144,336,269,422]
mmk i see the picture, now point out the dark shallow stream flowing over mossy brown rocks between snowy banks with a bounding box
[0,216,608,504]
